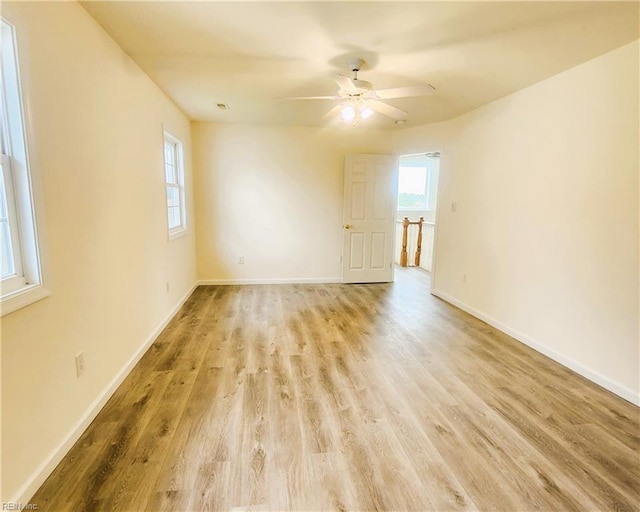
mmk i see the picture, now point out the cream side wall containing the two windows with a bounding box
[2,2,196,501]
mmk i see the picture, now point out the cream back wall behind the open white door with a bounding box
[192,123,391,282]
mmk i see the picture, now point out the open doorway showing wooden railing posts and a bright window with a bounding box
[393,152,440,273]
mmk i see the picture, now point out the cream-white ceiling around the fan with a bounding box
[82,1,640,129]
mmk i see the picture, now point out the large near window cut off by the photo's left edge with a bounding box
[0,19,50,315]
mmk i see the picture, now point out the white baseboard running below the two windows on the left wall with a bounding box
[9,283,198,503]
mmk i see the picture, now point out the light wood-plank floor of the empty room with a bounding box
[31,269,640,511]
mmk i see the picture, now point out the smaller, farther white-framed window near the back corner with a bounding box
[164,132,187,240]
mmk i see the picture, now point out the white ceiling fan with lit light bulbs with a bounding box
[283,58,436,124]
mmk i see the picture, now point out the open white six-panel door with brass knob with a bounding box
[342,155,396,283]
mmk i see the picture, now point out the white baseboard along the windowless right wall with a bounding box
[431,290,640,406]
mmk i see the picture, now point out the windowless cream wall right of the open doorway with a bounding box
[394,41,640,403]
